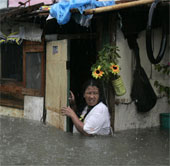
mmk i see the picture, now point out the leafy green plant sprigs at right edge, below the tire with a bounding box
[154,63,170,104]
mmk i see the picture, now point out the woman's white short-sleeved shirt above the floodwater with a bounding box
[73,102,110,135]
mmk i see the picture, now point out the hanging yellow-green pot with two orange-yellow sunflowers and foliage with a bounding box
[91,44,126,96]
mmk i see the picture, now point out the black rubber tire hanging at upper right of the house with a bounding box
[146,0,167,64]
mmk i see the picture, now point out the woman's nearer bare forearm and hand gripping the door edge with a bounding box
[61,107,90,136]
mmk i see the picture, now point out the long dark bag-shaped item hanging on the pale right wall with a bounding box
[128,37,157,112]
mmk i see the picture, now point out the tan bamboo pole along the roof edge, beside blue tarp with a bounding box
[84,0,154,15]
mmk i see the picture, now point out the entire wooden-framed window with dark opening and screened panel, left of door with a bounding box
[0,41,44,108]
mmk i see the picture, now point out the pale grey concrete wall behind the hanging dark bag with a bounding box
[115,29,170,131]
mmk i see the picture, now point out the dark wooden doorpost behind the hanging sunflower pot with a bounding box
[96,13,117,130]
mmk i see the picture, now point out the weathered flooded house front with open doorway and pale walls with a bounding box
[0,1,170,131]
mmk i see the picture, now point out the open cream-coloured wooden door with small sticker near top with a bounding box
[45,40,68,131]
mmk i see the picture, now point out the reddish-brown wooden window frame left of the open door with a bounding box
[0,40,45,109]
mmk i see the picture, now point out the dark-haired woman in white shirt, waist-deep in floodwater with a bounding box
[61,79,110,136]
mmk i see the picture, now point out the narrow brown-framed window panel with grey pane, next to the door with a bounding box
[23,41,45,96]
